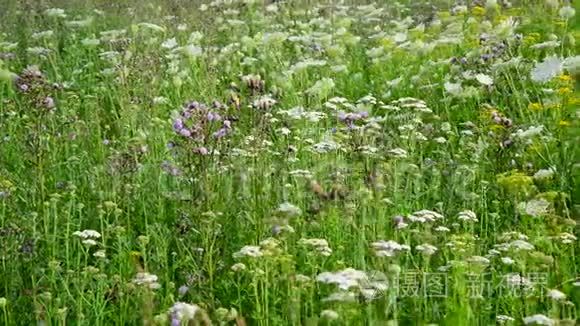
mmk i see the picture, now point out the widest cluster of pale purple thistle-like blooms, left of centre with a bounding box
[173,101,232,155]
